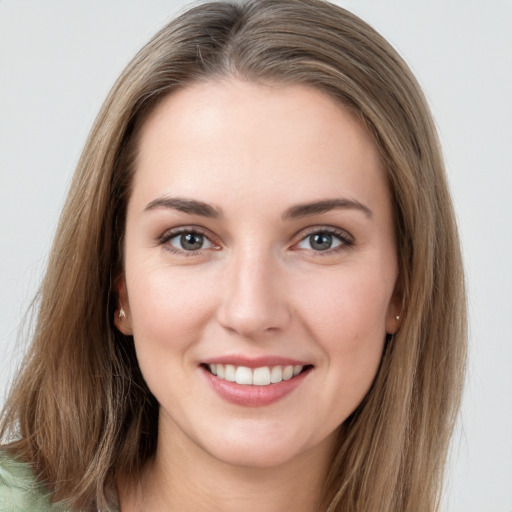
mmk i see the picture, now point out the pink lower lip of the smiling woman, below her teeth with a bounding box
[201,368,311,407]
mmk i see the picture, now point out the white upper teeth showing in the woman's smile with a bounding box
[208,364,304,386]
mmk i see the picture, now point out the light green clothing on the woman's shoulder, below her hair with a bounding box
[0,448,62,512]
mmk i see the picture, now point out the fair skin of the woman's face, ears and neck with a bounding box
[116,78,400,512]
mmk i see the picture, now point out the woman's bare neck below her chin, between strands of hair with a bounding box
[119,414,333,512]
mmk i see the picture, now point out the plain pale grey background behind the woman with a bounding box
[0,0,512,512]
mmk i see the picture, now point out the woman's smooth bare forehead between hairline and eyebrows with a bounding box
[129,79,387,214]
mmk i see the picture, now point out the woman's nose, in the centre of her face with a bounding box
[217,245,291,339]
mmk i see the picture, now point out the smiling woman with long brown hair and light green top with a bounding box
[0,0,465,512]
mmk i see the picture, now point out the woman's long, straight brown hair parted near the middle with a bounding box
[0,0,466,512]
